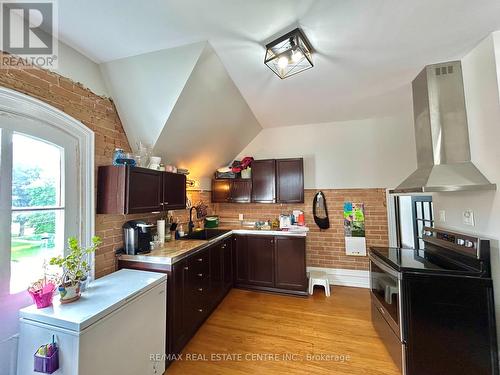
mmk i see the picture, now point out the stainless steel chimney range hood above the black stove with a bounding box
[391,61,496,193]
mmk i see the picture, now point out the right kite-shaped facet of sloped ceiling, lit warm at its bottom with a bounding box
[154,43,262,188]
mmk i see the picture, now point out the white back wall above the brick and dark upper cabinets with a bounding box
[238,104,417,189]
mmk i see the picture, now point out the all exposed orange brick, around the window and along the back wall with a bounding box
[0,52,388,277]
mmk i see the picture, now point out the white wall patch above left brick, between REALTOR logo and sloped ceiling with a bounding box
[54,42,109,96]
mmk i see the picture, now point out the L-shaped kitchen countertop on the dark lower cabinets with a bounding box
[119,226,307,265]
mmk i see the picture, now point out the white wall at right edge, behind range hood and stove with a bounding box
[433,32,500,346]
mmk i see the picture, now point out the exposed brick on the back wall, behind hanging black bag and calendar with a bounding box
[215,189,388,270]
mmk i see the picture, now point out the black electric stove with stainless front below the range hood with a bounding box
[369,228,499,375]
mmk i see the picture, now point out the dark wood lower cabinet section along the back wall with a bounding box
[233,235,307,295]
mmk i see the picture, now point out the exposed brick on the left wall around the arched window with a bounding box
[0,54,197,277]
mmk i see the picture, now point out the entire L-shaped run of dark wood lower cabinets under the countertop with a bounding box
[118,235,307,365]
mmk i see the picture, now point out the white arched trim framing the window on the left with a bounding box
[0,87,95,294]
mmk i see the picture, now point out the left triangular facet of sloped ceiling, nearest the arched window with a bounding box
[100,42,206,149]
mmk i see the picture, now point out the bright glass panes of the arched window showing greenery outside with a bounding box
[9,131,67,293]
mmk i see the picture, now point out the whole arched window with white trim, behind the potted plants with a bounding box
[0,87,94,357]
